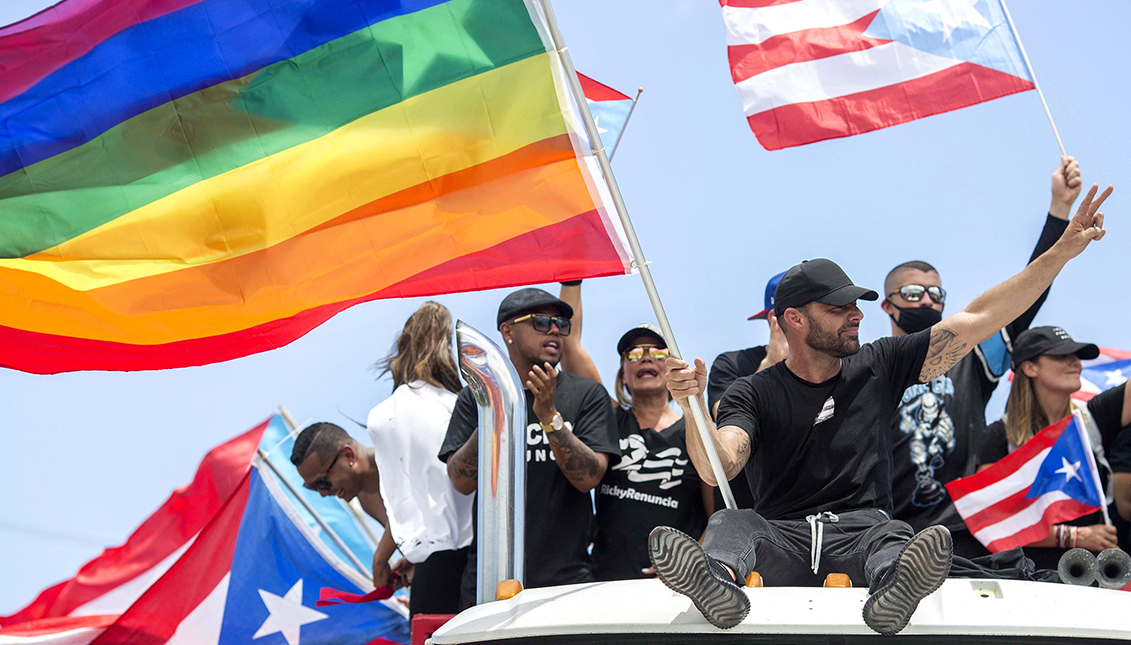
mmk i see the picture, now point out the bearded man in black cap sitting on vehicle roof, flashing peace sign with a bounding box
[648,181,1111,634]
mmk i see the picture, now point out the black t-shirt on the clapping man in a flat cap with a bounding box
[440,372,621,587]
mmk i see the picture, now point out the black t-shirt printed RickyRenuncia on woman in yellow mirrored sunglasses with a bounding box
[593,409,707,581]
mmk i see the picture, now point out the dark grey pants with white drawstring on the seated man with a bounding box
[702,509,914,587]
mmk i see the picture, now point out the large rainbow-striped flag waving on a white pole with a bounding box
[0,0,631,373]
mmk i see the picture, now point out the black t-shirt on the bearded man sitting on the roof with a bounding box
[718,330,931,519]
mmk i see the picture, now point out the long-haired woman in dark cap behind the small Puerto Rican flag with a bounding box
[978,327,1131,569]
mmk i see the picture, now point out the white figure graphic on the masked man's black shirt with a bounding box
[899,375,955,507]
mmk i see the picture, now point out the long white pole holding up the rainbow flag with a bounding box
[535,0,737,508]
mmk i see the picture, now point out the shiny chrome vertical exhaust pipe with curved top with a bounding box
[456,320,526,604]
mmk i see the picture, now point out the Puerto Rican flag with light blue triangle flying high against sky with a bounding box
[720,0,1035,151]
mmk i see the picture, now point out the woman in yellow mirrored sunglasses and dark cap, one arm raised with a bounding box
[561,283,713,581]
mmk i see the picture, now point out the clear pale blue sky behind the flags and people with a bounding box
[0,0,1131,614]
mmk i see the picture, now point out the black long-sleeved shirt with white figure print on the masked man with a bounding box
[891,215,1068,531]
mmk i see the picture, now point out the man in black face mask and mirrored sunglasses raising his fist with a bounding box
[880,157,1082,558]
